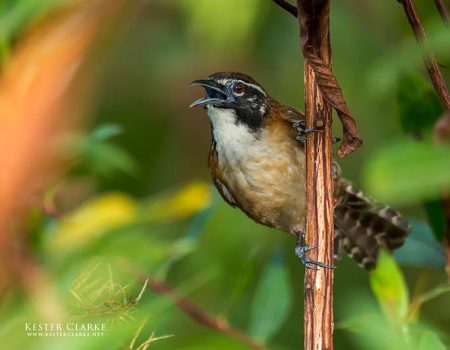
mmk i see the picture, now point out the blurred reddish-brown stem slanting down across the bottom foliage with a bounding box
[144,278,266,350]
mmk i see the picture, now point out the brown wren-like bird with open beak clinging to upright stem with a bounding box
[190,72,411,270]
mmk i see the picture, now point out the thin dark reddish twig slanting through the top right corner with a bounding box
[400,0,450,109]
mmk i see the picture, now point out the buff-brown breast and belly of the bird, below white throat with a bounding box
[209,117,306,232]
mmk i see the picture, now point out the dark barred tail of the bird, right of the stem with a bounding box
[334,179,411,270]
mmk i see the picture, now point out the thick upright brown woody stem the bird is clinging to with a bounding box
[298,0,332,350]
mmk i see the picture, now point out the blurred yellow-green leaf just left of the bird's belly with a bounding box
[142,182,212,222]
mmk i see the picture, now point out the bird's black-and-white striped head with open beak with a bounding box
[190,72,270,129]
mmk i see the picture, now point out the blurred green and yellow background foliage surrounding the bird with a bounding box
[0,0,450,350]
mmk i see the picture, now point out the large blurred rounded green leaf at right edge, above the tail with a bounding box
[364,139,450,204]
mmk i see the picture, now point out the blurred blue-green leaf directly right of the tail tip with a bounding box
[394,220,446,268]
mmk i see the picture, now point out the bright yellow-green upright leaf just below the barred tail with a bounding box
[370,251,409,323]
